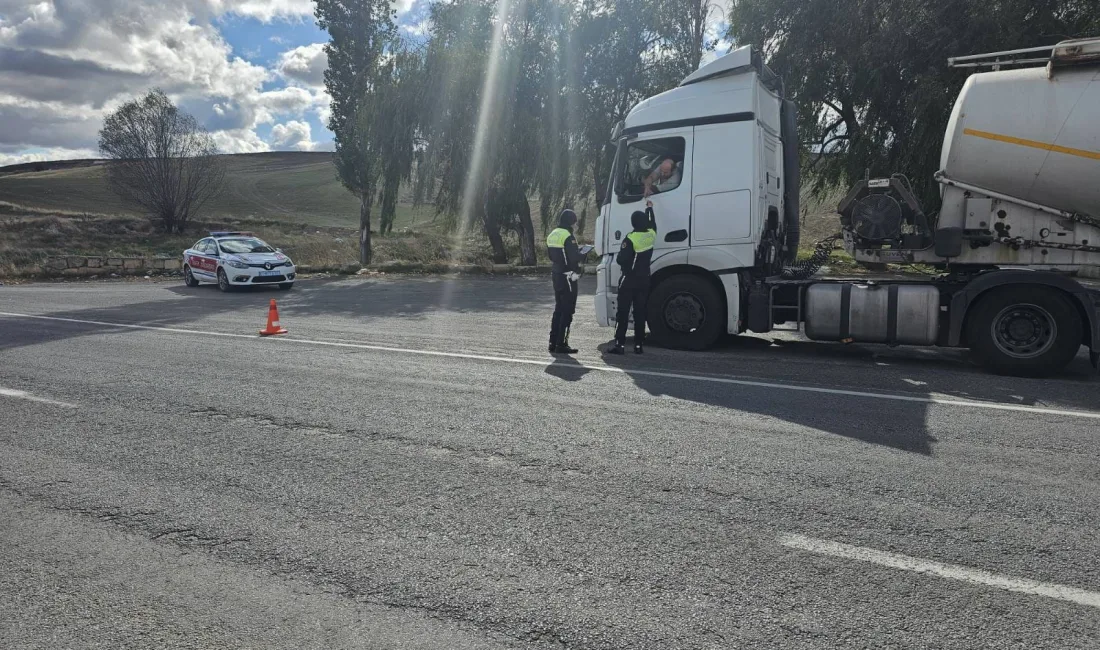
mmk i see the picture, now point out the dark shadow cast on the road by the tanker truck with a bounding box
[602,337,1100,455]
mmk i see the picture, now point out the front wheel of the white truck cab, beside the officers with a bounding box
[647,274,726,350]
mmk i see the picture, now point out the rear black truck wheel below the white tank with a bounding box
[967,285,1084,377]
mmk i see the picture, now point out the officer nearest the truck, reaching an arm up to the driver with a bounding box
[607,201,657,354]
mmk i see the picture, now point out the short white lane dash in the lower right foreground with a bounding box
[779,535,1100,607]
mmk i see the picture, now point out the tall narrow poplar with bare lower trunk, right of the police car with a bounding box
[315,0,397,266]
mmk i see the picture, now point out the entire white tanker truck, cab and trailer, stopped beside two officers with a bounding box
[595,38,1100,375]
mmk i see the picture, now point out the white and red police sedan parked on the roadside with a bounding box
[184,232,297,291]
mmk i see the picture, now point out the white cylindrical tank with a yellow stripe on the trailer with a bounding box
[938,38,1100,219]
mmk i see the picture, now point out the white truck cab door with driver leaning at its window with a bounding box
[604,128,692,296]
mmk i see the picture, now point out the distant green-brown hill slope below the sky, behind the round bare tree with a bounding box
[0,152,432,228]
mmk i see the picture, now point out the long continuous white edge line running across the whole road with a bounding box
[0,311,1100,420]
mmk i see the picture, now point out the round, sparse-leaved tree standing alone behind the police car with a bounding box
[99,90,226,233]
